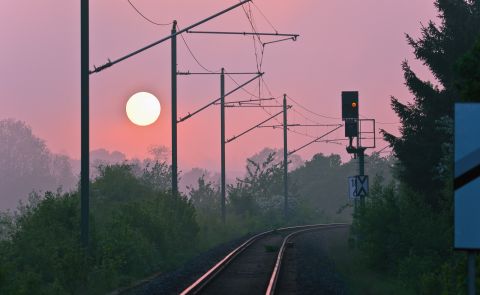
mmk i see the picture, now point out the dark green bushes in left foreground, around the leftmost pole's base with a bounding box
[0,165,198,294]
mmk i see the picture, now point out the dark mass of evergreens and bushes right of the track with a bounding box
[353,0,480,294]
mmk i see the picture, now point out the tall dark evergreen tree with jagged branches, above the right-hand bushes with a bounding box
[382,0,480,208]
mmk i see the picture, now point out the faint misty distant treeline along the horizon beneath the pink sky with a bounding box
[0,119,391,217]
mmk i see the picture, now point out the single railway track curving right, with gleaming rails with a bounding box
[181,223,349,295]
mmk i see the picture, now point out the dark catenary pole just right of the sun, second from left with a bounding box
[171,20,178,196]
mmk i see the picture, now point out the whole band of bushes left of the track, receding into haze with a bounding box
[0,150,390,294]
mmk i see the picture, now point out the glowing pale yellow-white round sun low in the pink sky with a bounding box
[125,92,162,126]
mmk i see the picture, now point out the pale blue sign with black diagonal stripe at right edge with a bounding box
[454,103,480,250]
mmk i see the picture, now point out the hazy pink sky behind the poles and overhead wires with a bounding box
[0,0,437,170]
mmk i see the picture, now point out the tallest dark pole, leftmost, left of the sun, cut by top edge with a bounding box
[80,0,90,248]
